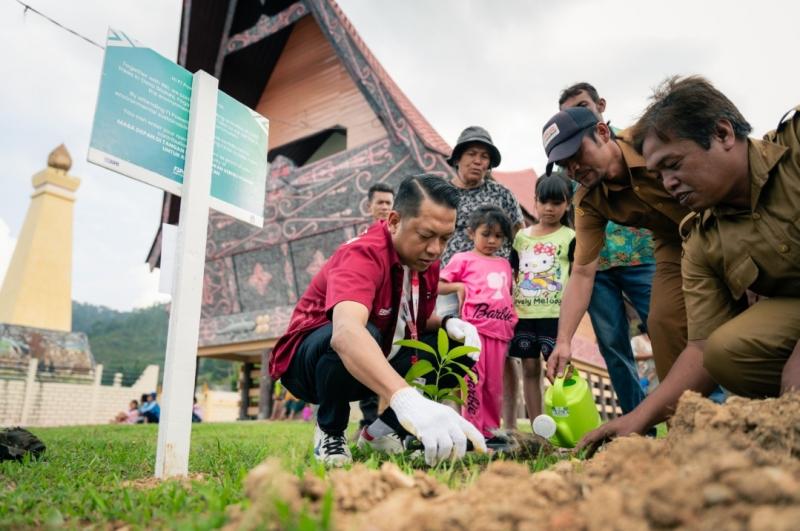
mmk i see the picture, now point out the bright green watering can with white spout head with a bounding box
[533,366,600,448]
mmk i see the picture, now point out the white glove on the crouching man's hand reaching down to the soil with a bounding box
[389,387,486,466]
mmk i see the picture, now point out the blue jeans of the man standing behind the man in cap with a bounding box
[589,264,656,413]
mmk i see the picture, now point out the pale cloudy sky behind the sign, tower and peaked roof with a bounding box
[0,0,800,309]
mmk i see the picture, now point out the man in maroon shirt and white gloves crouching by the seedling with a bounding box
[270,175,486,466]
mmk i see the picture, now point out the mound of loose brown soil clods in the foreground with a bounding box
[230,393,800,531]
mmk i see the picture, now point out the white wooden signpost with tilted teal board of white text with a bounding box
[88,29,269,478]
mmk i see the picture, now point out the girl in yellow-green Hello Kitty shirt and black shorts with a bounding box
[508,175,575,426]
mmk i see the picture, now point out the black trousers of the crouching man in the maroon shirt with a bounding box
[281,323,473,435]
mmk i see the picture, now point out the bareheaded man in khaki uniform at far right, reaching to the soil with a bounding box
[583,77,800,445]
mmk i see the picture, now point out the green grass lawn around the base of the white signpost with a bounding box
[0,422,564,529]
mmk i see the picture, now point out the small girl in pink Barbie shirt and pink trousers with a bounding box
[439,205,517,443]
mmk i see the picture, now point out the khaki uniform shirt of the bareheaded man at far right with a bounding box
[681,106,800,340]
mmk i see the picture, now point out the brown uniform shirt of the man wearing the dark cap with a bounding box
[573,130,689,265]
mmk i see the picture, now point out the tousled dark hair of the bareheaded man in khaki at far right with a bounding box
[632,76,753,153]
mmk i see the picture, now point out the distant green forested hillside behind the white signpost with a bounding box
[72,301,239,389]
